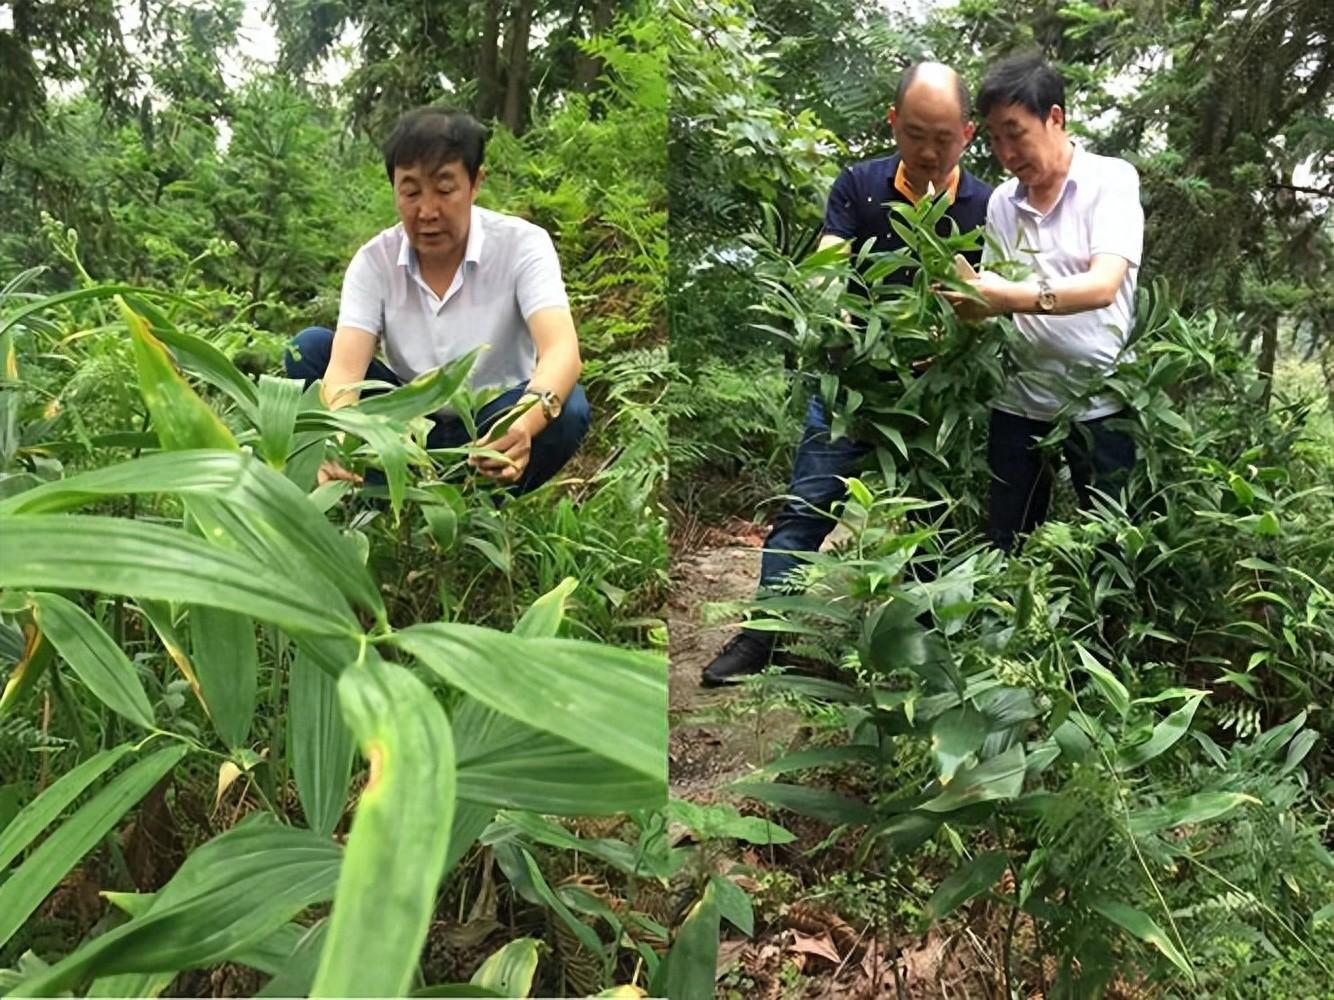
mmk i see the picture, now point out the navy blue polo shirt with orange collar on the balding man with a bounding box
[824,153,991,284]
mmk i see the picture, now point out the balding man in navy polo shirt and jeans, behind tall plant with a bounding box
[702,63,991,687]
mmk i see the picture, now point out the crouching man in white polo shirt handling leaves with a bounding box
[284,108,588,492]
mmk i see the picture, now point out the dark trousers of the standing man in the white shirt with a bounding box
[987,409,1135,552]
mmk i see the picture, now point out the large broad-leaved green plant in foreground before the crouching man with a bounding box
[0,287,666,996]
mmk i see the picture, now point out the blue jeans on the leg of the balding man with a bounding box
[759,396,872,593]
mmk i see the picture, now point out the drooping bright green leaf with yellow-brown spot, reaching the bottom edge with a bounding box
[311,656,455,996]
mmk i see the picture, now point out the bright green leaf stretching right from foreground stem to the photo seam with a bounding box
[388,623,667,799]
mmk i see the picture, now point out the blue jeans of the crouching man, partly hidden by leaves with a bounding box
[283,327,588,493]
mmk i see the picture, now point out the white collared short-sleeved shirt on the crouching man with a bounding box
[338,205,570,389]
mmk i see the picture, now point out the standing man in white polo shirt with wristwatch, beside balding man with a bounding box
[947,55,1145,551]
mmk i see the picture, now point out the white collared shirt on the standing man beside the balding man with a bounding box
[983,147,1145,420]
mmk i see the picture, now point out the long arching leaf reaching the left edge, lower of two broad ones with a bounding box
[0,515,360,636]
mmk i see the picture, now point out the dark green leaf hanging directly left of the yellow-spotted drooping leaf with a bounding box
[287,648,356,837]
